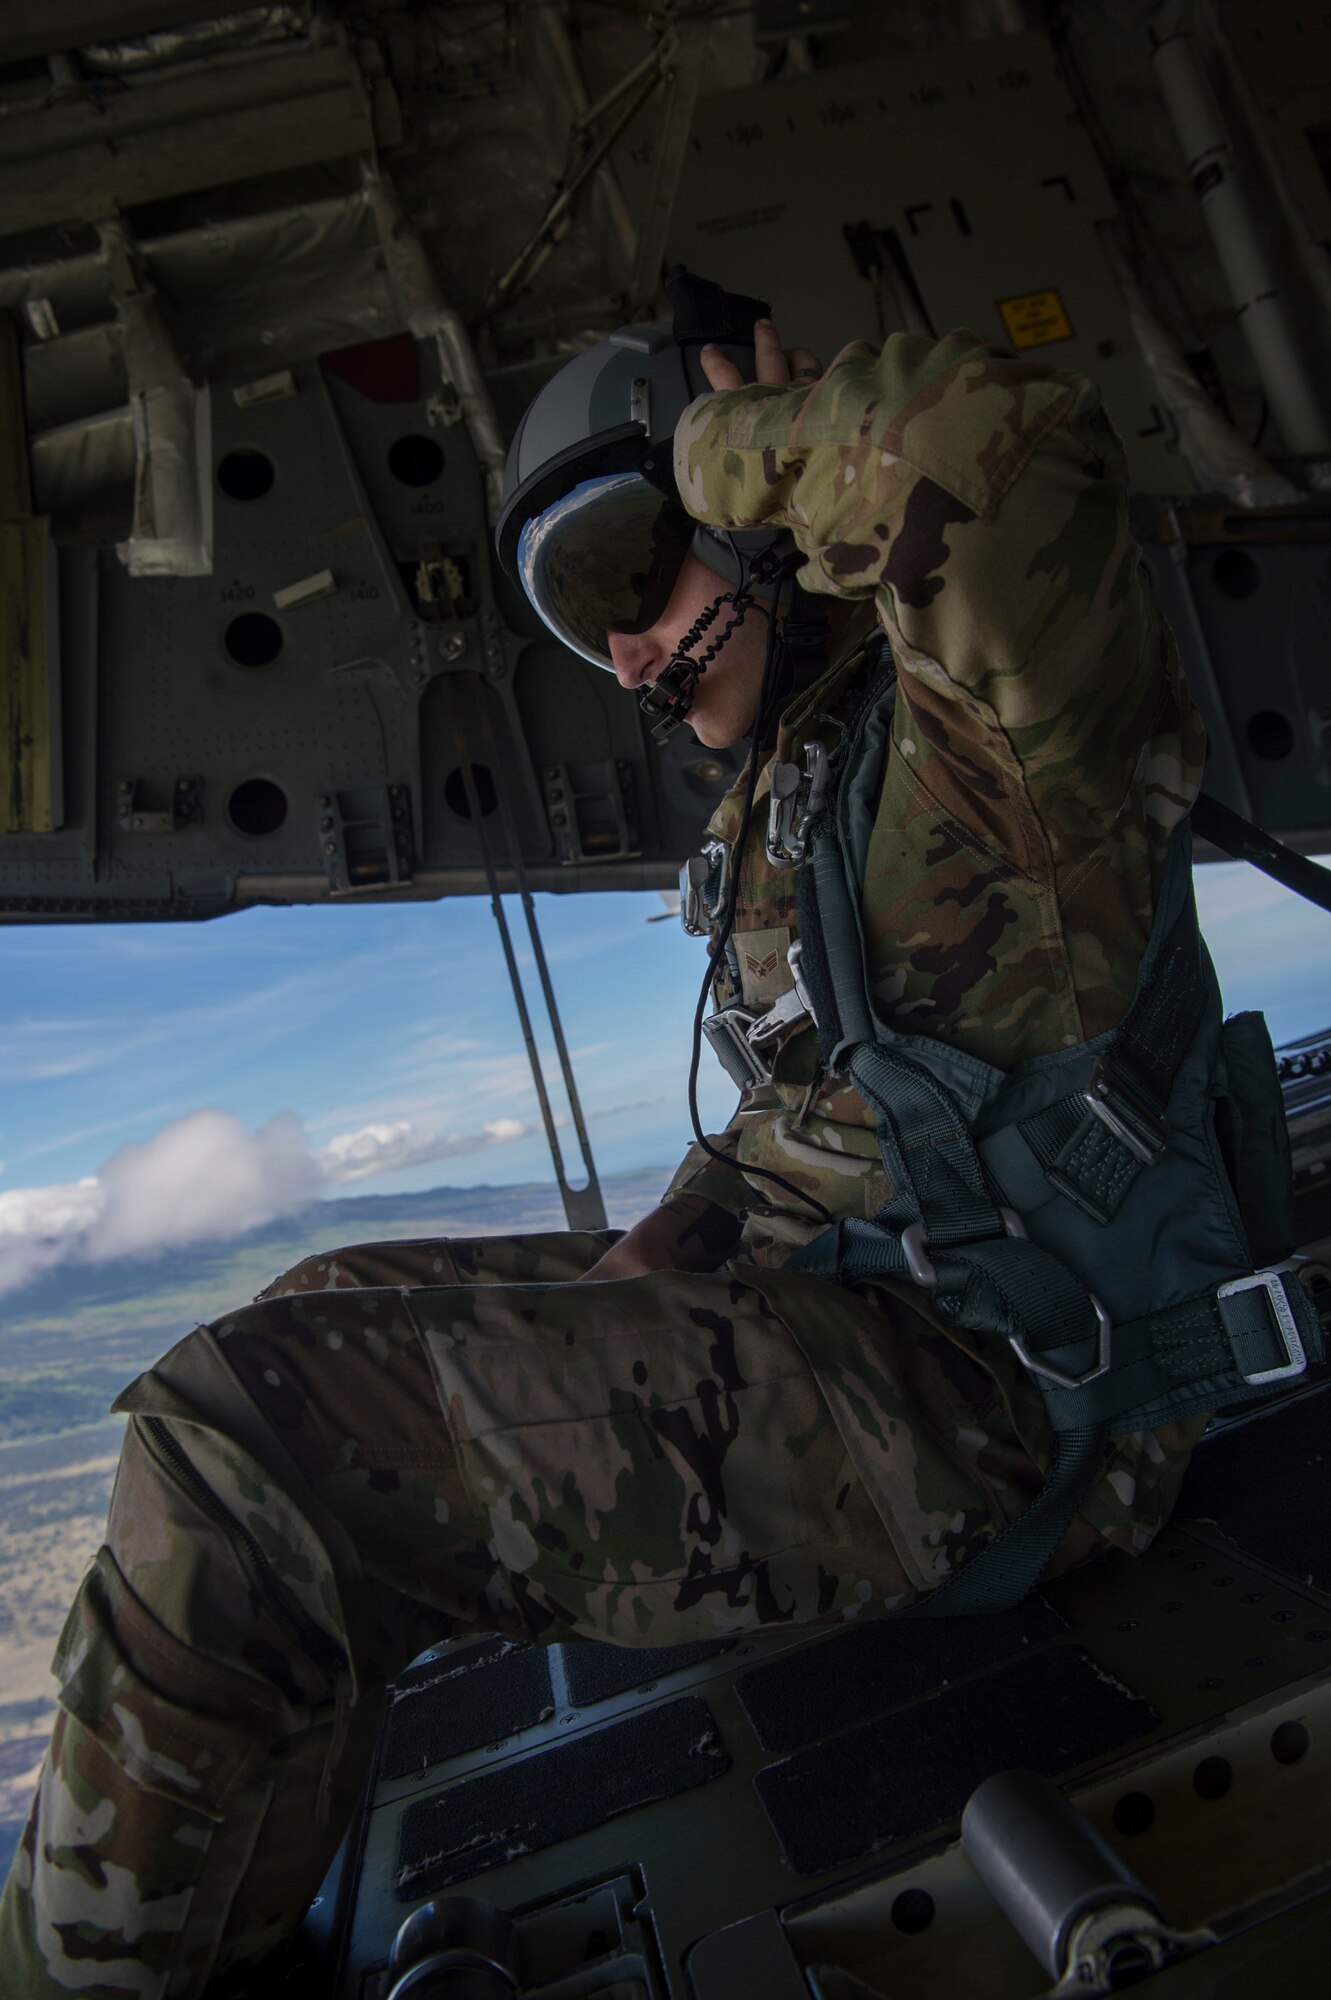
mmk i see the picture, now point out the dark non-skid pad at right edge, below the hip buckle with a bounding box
[1175,1388,1331,1590]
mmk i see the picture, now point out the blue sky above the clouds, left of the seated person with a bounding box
[0,894,733,1194]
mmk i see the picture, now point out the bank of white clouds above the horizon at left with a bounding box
[0,1110,534,1294]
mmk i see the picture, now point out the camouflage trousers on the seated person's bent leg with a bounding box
[0,1234,1189,2000]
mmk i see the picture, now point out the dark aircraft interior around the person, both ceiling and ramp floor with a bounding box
[0,0,1331,2000]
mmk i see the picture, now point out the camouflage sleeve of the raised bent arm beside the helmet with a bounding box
[675,332,1201,876]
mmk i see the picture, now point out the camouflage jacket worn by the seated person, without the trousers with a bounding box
[669,332,1205,1264]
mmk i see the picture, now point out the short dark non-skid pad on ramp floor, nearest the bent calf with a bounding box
[380,1638,554,1778]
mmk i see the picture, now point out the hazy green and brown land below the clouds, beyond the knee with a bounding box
[0,1168,667,1872]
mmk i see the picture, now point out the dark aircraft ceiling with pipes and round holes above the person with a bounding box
[0,0,1331,922]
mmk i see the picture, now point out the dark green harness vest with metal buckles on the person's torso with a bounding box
[713,648,1325,1614]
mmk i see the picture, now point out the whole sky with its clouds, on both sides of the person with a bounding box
[0,862,1331,1292]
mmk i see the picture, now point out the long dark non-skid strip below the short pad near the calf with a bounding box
[394,1694,729,1902]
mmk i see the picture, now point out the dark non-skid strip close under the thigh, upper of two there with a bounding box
[735,1598,1067,1750]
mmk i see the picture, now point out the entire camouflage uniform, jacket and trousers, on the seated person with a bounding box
[0,334,1201,2000]
